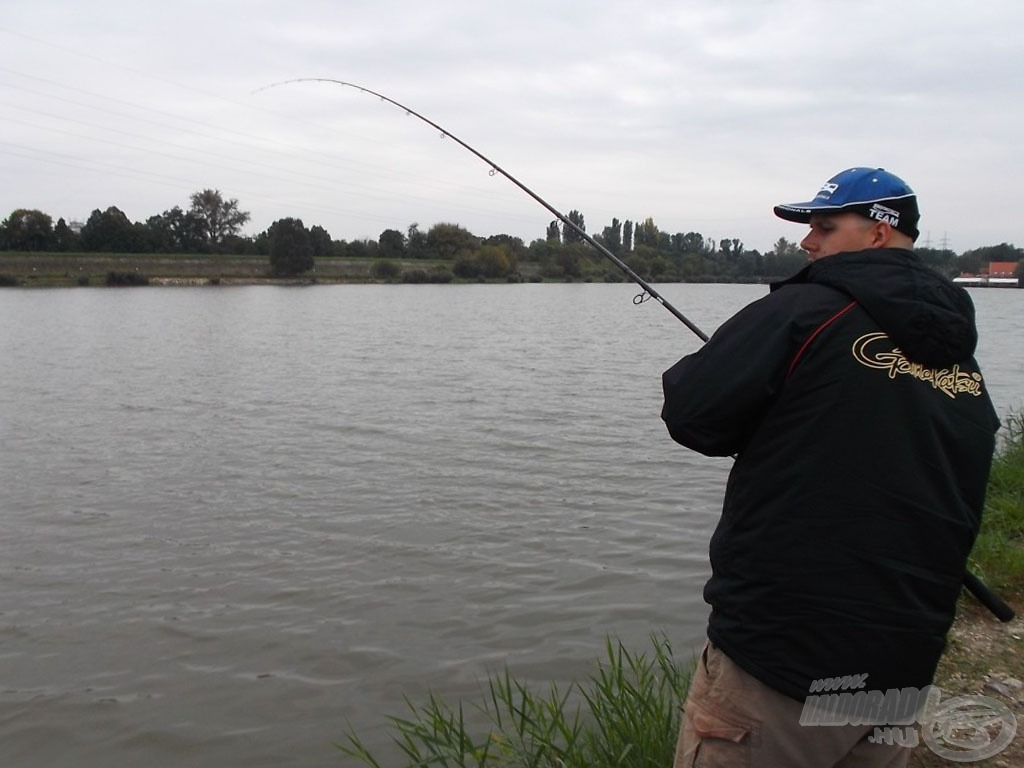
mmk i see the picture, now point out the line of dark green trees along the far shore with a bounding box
[0,189,1024,282]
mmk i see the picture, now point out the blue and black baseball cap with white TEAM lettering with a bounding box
[775,168,921,240]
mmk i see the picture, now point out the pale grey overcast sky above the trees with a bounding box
[0,0,1024,252]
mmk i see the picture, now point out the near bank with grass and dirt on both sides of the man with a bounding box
[339,415,1024,768]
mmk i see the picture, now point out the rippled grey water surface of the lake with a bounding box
[0,285,1024,768]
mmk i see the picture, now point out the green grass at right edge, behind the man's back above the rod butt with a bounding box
[971,413,1024,588]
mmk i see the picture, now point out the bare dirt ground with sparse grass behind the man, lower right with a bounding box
[909,591,1024,768]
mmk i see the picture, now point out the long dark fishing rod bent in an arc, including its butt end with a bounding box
[253,78,1014,622]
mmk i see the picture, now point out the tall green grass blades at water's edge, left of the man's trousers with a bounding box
[338,637,691,768]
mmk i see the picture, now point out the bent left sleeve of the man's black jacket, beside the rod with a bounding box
[662,291,801,456]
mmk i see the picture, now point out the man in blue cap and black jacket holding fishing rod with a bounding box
[662,168,998,768]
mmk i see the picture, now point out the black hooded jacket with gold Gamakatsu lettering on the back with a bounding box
[662,249,998,700]
